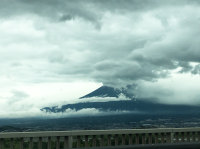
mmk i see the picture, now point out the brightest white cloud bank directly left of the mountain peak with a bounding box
[0,82,101,118]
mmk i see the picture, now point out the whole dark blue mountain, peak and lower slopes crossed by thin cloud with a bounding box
[41,86,200,115]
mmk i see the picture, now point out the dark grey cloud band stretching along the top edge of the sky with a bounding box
[0,0,199,23]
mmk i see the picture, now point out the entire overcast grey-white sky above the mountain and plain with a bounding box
[0,0,200,117]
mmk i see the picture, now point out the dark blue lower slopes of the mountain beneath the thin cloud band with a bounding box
[41,100,200,114]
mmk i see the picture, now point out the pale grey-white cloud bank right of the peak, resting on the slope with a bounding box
[134,69,200,105]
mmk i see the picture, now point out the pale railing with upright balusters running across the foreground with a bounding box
[0,128,200,149]
